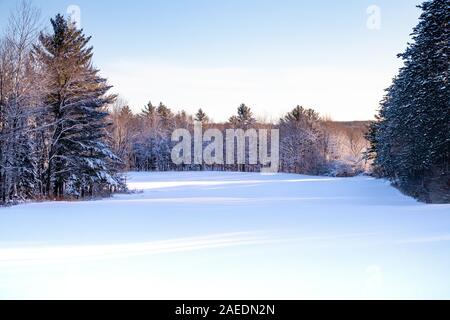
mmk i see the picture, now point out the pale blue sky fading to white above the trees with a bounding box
[0,0,421,120]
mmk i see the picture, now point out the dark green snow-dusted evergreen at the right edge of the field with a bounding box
[369,0,450,202]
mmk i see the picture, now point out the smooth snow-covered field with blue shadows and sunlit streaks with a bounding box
[0,173,450,299]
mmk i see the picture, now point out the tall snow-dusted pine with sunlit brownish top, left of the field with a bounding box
[34,15,120,197]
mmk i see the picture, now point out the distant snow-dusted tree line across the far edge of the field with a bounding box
[110,99,370,176]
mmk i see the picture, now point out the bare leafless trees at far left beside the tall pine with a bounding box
[0,1,40,202]
